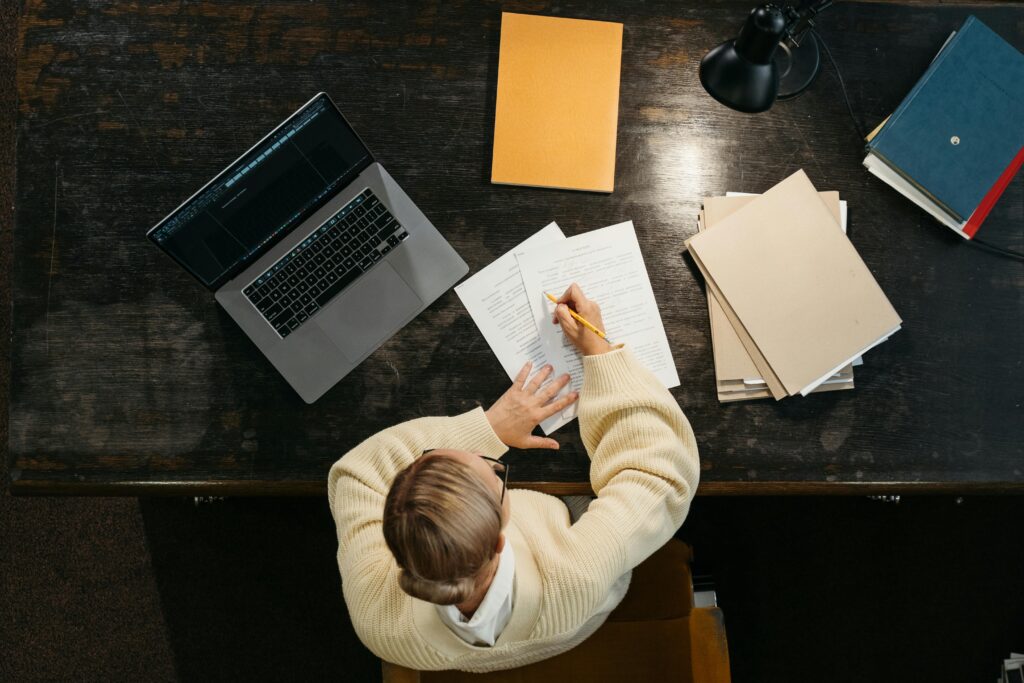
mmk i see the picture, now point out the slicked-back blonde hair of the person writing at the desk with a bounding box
[384,454,502,605]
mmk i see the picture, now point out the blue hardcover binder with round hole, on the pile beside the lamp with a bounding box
[867,16,1024,238]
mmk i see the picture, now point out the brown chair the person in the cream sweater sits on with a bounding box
[382,540,730,683]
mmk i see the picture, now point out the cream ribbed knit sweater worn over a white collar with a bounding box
[328,349,699,672]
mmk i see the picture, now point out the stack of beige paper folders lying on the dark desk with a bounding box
[686,171,901,401]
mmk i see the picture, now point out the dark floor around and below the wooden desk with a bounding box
[0,5,1024,683]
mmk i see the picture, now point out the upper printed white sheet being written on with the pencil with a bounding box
[513,221,679,433]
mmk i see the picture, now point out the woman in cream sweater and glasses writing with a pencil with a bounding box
[329,285,699,672]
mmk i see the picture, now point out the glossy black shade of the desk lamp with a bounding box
[700,4,785,114]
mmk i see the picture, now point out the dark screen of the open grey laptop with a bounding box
[148,93,373,289]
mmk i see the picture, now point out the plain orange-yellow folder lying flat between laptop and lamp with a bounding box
[490,12,623,193]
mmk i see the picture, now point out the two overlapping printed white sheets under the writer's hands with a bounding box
[455,221,679,434]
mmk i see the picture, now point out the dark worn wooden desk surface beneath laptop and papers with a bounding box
[9,0,1024,495]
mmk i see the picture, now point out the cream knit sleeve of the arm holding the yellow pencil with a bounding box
[573,348,700,583]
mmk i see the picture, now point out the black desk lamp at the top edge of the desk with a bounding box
[700,0,833,114]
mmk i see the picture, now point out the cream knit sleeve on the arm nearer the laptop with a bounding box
[328,409,508,642]
